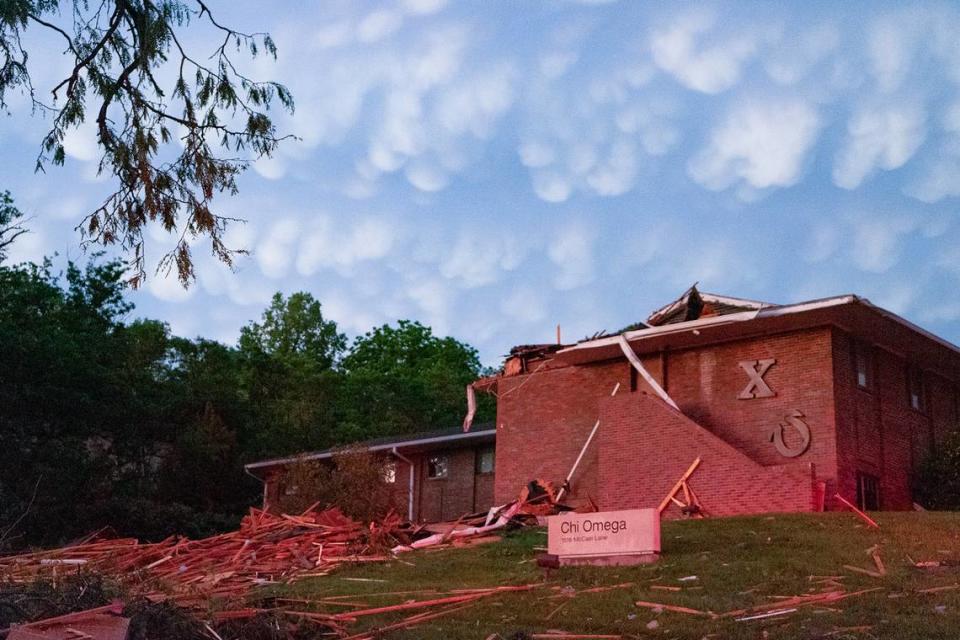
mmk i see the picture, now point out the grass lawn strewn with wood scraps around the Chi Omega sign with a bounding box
[272,513,960,640]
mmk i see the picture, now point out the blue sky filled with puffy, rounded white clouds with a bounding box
[0,0,960,364]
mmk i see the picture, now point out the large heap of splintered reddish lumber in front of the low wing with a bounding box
[0,494,564,606]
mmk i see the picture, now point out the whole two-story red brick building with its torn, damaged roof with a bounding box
[484,287,960,515]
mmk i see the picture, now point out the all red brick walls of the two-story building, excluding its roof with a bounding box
[494,318,958,515]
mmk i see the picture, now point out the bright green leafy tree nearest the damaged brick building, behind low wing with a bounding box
[339,320,491,441]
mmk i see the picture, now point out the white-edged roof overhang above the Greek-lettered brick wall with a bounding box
[555,295,960,379]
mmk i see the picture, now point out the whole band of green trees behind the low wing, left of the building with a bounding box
[0,219,492,549]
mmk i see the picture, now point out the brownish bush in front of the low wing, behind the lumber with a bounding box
[279,448,397,522]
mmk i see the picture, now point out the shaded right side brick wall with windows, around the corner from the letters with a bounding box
[828,330,957,509]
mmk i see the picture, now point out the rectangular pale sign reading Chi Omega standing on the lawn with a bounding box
[547,509,660,564]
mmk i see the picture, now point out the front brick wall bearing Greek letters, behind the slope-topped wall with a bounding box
[495,328,837,503]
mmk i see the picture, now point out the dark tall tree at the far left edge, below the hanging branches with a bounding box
[0,255,132,539]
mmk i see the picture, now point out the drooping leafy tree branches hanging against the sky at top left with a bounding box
[0,0,293,285]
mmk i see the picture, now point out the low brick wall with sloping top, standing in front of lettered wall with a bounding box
[597,393,814,517]
